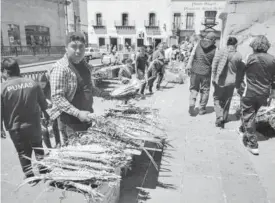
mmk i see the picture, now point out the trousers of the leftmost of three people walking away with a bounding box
[189,73,211,109]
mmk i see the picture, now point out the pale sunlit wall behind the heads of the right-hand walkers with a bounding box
[221,0,275,57]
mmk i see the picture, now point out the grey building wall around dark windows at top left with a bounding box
[1,0,65,46]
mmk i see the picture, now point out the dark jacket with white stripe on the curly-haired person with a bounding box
[240,53,275,97]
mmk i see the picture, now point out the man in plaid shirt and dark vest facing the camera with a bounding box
[49,32,109,144]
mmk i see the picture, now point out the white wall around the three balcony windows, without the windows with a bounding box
[88,0,169,47]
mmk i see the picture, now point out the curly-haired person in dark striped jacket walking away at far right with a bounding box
[238,35,275,155]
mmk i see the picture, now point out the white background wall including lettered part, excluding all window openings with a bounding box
[88,0,226,45]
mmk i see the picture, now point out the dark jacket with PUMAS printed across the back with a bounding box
[1,77,48,131]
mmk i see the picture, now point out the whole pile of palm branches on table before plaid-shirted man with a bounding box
[20,105,166,201]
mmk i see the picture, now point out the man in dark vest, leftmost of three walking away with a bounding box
[187,32,216,116]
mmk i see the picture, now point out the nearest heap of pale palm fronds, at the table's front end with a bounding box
[19,144,131,201]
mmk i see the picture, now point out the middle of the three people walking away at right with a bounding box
[212,37,245,128]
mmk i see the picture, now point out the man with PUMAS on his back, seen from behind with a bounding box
[1,58,49,182]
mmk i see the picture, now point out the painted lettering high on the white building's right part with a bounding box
[184,1,224,11]
